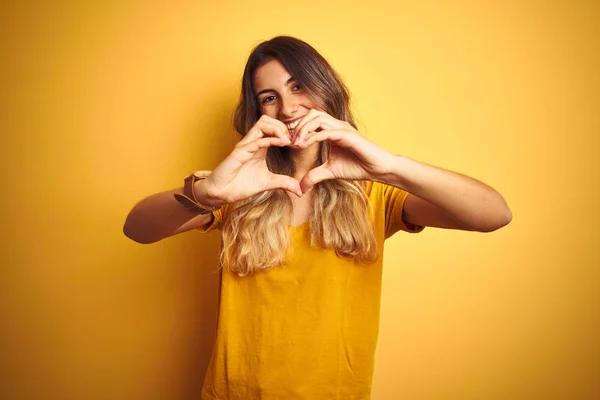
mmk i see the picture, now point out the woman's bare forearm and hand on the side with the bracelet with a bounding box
[123,115,302,244]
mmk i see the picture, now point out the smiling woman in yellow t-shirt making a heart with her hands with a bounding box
[124,37,511,400]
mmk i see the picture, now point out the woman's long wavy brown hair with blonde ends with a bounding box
[221,36,378,276]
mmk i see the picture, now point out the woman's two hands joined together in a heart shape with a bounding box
[206,110,396,203]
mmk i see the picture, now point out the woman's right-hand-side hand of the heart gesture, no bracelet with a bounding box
[293,110,396,193]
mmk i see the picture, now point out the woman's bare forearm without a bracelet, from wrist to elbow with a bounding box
[380,156,512,231]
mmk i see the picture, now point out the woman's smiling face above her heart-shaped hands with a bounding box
[254,59,318,135]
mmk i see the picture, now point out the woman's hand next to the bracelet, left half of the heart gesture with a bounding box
[202,115,302,203]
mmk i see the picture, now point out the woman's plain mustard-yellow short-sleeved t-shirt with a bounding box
[201,182,423,400]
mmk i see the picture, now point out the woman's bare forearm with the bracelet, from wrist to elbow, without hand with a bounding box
[123,181,216,244]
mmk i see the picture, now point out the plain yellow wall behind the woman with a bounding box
[0,0,600,400]
